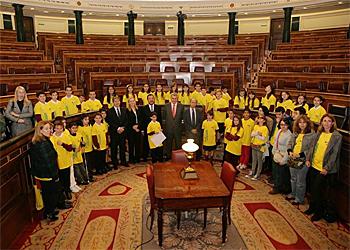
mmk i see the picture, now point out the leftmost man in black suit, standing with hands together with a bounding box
[106,96,127,169]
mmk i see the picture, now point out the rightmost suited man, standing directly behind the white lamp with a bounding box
[184,98,203,161]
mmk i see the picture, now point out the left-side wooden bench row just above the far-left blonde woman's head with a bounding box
[0,73,67,95]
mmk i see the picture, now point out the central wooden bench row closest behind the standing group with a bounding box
[74,61,245,87]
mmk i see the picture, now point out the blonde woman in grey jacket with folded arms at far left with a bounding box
[5,86,33,136]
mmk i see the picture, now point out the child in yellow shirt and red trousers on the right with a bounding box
[239,107,255,169]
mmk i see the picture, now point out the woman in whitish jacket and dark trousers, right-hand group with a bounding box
[269,118,292,194]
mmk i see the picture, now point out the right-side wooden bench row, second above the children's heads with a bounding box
[266,59,350,73]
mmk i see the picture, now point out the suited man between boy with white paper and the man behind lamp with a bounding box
[164,93,184,159]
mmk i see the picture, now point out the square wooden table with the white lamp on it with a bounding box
[154,161,230,246]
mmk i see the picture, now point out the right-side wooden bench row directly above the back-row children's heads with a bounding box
[258,72,350,95]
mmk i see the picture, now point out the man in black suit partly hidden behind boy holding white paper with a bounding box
[141,94,162,161]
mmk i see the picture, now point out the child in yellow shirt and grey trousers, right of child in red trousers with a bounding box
[245,116,269,180]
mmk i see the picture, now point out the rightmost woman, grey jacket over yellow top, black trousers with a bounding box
[305,114,342,222]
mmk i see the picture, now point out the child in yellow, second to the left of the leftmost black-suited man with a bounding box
[78,114,94,182]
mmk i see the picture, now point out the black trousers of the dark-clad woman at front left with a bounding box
[40,180,59,215]
